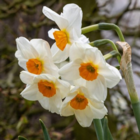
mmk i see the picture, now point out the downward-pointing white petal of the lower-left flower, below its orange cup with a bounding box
[39,93,62,114]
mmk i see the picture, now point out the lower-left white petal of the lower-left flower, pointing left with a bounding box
[21,84,43,101]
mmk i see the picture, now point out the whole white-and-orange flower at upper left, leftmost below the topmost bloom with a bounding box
[15,37,58,76]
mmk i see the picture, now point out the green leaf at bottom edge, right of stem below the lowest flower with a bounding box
[102,117,113,140]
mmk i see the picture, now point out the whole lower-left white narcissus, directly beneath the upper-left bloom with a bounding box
[20,71,70,114]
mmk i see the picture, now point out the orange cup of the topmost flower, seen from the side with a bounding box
[53,31,69,51]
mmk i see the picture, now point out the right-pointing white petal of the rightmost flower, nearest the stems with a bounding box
[99,63,122,88]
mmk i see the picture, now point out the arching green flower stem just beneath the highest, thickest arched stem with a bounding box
[90,39,121,63]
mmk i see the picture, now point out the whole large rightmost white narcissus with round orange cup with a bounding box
[59,43,121,101]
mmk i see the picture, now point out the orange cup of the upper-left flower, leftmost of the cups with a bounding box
[26,59,42,75]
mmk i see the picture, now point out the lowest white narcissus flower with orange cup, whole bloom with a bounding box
[60,87,107,127]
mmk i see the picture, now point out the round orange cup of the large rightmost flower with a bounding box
[79,62,98,81]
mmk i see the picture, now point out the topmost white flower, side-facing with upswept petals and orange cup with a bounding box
[43,4,89,63]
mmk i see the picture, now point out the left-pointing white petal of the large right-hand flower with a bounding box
[59,59,81,80]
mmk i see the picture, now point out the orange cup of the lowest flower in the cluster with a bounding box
[70,94,88,110]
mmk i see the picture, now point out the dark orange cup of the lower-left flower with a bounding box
[38,80,56,98]
